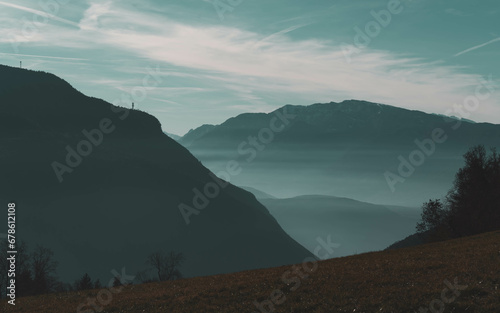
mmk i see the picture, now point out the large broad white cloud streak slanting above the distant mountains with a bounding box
[52,1,489,120]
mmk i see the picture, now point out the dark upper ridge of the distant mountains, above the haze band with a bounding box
[180,100,492,147]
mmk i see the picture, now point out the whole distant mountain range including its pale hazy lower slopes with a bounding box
[179,100,500,207]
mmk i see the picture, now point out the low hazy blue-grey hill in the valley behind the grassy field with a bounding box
[260,196,418,257]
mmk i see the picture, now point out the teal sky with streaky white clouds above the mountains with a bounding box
[0,0,500,135]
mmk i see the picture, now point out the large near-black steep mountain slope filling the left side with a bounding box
[0,66,311,281]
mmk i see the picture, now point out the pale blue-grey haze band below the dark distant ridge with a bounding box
[187,147,460,206]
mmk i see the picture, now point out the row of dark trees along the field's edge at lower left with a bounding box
[0,240,185,299]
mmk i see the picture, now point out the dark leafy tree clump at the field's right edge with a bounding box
[417,145,500,242]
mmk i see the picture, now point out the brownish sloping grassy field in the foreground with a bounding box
[1,231,500,313]
